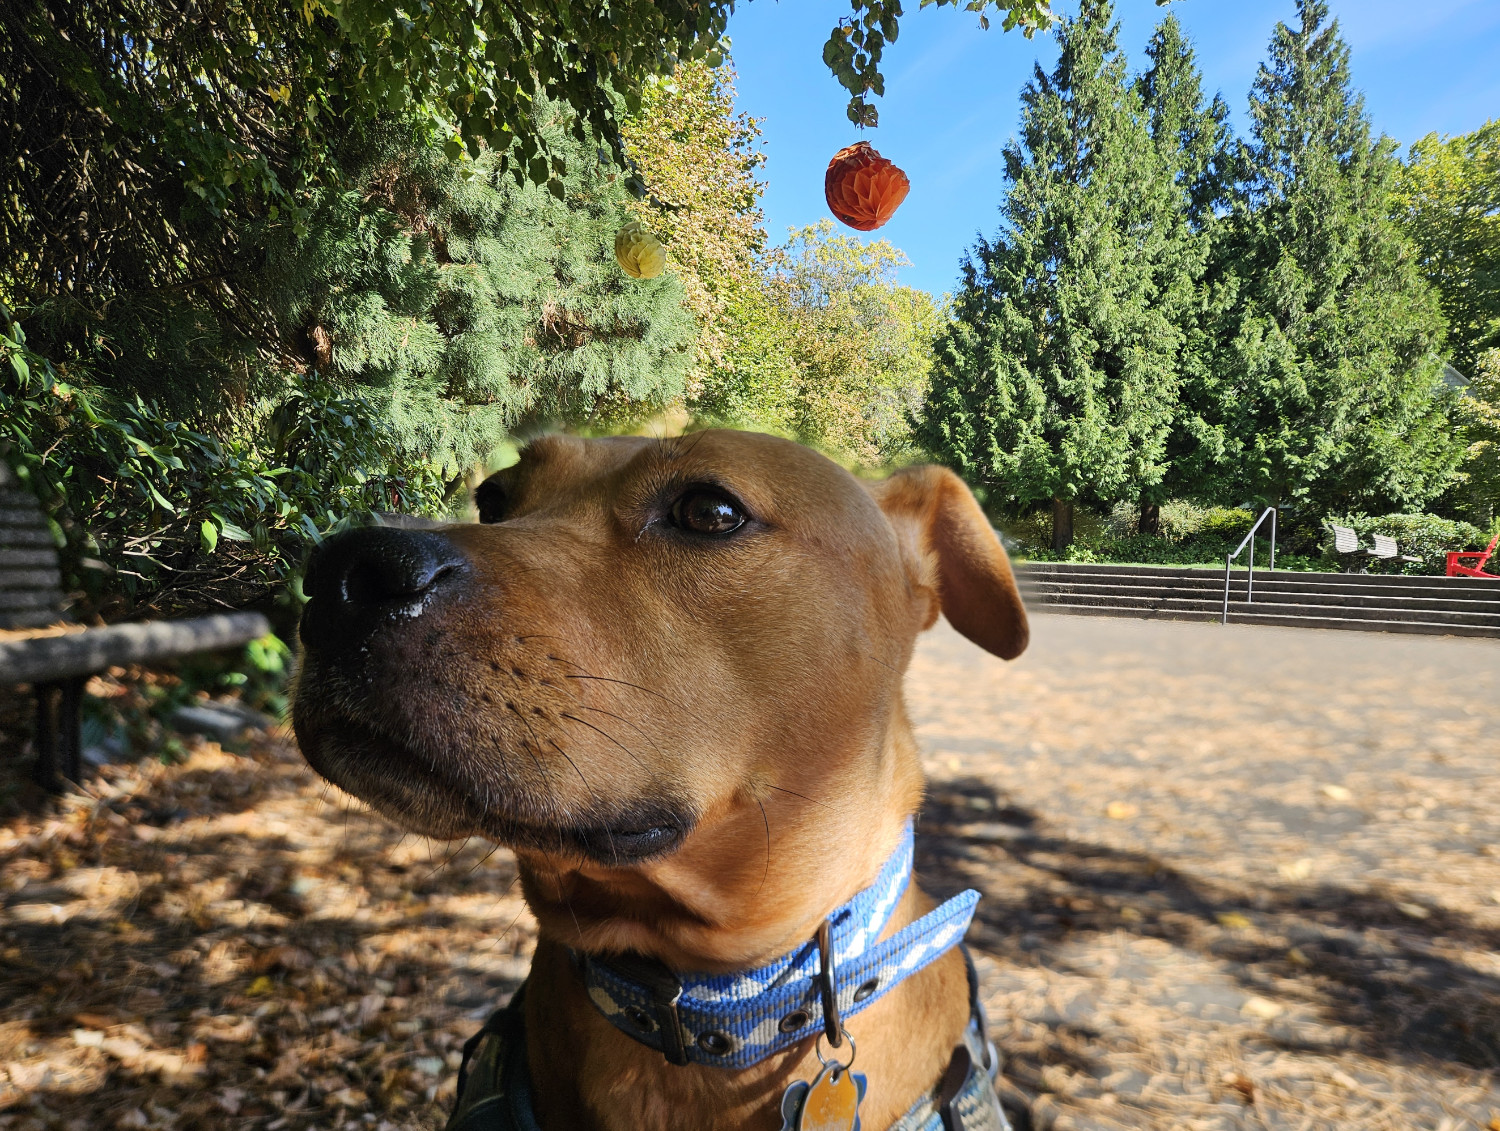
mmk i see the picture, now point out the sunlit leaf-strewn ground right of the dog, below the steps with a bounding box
[911,615,1500,1131]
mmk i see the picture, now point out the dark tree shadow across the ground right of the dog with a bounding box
[917,777,1500,1122]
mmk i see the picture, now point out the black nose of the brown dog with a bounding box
[299,527,470,651]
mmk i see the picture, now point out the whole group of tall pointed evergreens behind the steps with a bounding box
[921,0,1463,545]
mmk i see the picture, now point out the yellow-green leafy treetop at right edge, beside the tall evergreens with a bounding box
[1392,119,1500,375]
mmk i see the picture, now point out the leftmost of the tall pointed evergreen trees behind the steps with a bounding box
[920,0,1194,551]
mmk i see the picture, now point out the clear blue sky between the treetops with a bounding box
[729,0,1500,293]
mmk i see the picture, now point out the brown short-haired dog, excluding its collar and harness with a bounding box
[293,431,1028,1131]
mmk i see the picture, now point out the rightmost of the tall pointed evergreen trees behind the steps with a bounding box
[1211,0,1460,512]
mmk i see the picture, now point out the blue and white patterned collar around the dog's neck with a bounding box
[578,821,980,1068]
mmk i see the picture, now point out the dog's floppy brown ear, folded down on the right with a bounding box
[869,465,1031,660]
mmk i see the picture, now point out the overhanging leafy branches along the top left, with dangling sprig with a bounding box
[0,0,1050,366]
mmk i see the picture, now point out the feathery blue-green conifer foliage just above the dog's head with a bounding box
[260,108,695,476]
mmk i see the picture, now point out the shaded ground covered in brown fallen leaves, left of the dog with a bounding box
[0,743,530,1131]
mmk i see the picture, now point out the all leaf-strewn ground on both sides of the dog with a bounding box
[0,617,1500,1131]
